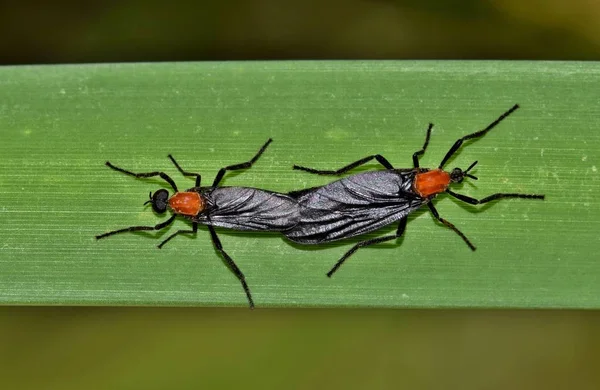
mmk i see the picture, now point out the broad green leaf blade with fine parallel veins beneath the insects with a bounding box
[0,61,600,308]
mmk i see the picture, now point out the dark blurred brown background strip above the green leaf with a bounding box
[0,0,600,64]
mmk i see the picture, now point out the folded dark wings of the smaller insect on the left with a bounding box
[194,187,300,231]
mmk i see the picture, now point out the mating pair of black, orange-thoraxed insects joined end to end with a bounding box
[96,105,544,308]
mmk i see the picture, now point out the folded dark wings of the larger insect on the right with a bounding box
[284,170,427,244]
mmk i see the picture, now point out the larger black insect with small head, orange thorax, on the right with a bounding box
[284,105,544,277]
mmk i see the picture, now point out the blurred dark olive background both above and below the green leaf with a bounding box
[0,0,600,389]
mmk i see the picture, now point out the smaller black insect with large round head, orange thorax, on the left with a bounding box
[96,139,299,308]
